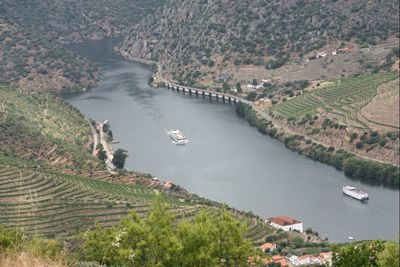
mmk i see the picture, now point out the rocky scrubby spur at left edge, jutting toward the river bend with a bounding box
[0,19,99,91]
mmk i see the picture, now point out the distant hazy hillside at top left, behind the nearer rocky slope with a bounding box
[0,0,165,43]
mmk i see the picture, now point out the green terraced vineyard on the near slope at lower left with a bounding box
[0,165,272,241]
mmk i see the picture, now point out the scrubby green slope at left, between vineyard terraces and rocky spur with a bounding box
[0,86,98,168]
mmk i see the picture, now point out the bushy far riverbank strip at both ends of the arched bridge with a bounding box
[114,49,400,189]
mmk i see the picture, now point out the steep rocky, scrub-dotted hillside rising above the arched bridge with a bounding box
[119,0,399,87]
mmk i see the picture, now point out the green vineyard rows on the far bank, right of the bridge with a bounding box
[271,73,398,128]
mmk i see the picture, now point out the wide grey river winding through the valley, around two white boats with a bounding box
[66,40,399,242]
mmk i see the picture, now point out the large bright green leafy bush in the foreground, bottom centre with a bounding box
[79,200,254,266]
